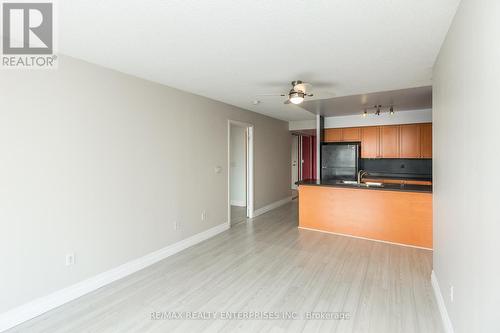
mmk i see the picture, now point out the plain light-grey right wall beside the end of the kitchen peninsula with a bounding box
[433,0,500,333]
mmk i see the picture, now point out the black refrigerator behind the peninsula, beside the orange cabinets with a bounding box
[321,143,360,180]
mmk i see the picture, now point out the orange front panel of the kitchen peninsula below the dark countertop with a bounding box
[299,185,432,249]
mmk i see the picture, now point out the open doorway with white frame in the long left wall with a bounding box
[228,120,253,226]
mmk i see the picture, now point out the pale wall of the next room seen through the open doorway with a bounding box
[229,125,247,206]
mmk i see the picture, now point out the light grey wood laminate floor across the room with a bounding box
[11,202,441,333]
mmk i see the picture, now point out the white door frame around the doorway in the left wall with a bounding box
[227,119,254,225]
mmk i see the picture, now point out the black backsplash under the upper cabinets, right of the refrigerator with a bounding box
[360,158,432,179]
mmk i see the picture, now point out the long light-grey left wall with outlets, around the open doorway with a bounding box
[0,56,291,313]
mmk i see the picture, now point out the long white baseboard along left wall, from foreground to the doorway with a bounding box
[0,219,230,332]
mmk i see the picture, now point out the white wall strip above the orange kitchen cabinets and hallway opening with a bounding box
[288,109,432,131]
